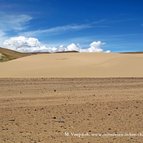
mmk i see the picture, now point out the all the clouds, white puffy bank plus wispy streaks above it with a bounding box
[0,12,110,53]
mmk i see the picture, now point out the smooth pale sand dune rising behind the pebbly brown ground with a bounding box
[0,53,143,77]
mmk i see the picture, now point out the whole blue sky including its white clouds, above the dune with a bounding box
[0,0,143,53]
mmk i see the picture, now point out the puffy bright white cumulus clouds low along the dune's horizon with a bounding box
[3,36,110,53]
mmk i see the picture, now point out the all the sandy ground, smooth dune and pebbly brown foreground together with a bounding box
[0,53,143,143]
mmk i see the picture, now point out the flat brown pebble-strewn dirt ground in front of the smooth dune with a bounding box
[0,78,143,143]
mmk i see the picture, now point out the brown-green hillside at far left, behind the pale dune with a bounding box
[0,47,31,62]
